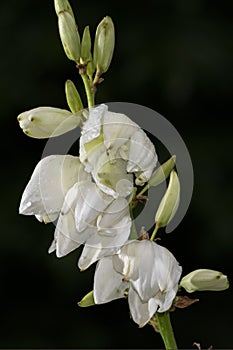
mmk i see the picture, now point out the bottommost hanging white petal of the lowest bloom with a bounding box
[128,286,157,327]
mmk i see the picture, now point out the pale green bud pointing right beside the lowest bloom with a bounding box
[180,269,229,293]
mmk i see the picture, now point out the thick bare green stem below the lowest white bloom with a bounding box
[155,311,178,350]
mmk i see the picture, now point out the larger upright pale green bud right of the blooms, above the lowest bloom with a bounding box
[155,170,180,227]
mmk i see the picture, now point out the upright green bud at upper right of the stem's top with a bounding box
[93,16,115,73]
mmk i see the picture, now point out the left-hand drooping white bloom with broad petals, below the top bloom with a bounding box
[19,155,131,270]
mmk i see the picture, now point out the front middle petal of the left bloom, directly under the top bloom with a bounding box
[75,182,113,232]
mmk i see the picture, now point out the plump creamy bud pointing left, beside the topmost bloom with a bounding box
[17,107,80,139]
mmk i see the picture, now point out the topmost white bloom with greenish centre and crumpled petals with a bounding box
[80,104,157,197]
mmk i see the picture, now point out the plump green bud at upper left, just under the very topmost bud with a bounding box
[58,11,80,62]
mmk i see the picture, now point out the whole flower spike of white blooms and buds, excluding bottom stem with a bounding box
[18,0,228,327]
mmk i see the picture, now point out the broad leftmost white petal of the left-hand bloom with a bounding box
[19,155,82,222]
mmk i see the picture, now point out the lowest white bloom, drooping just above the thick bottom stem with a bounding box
[94,240,182,327]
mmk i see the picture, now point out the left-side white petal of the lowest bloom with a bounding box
[94,257,128,304]
